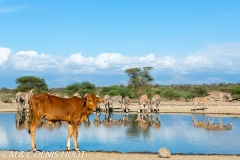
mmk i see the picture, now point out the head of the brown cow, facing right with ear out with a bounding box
[84,93,104,112]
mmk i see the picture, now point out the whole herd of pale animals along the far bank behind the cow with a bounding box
[16,89,232,113]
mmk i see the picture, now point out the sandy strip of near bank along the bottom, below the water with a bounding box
[0,150,240,160]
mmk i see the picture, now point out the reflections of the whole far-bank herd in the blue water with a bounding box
[15,112,232,131]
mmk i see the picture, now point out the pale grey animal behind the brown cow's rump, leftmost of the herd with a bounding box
[16,89,33,111]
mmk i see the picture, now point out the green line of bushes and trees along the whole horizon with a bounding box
[0,67,240,101]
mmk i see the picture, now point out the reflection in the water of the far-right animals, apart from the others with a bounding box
[192,114,232,131]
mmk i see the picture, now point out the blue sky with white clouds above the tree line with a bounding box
[0,0,240,88]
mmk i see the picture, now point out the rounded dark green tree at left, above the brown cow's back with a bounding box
[15,76,48,93]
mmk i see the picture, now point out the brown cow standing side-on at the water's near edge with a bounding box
[29,93,103,151]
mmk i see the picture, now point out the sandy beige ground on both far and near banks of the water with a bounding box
[0,101,240,160]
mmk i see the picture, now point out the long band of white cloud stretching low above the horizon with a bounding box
[0,43,240,81]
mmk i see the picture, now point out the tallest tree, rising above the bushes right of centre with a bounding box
[125,67,154,96]
